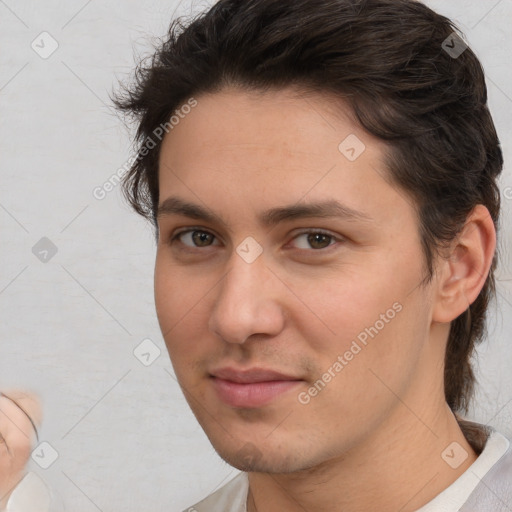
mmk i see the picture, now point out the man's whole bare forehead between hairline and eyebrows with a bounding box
[159,89,412,227]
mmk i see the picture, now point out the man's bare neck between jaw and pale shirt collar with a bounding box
[247,401,477,512]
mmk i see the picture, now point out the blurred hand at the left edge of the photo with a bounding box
[0,390,42,510]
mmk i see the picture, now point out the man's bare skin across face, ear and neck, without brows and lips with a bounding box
[155,88,495,512]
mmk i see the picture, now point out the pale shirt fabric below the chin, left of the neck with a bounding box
[183,473,249,512]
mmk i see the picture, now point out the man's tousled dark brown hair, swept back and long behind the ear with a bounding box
[114,0,503,444]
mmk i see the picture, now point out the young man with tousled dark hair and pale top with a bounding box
[112,0,512,512]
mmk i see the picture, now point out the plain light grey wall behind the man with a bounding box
[0,0,512,512]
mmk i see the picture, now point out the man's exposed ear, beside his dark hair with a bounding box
[432,204,496,323]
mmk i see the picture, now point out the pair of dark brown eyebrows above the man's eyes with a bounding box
[156,196,374,227]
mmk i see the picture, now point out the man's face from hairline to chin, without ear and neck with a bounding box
[155,89,442,472]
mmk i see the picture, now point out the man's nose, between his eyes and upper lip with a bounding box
[209,253,285,344]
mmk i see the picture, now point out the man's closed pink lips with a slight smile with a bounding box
[210,368,304,408]
